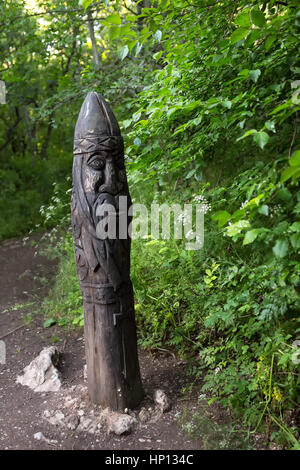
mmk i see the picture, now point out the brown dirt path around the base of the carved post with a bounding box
[0,236,202,450]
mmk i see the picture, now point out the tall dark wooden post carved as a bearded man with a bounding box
[71,92,143,411]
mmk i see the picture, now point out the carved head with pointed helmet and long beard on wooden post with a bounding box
[72,92,131,289]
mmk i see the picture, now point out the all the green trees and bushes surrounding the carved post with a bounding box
[0,0,300,448]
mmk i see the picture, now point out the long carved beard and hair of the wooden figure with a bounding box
[73,156,130,291]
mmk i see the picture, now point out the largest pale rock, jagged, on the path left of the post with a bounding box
[16,346,61,392]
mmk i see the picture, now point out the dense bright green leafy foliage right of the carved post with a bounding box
[120,1,300,446]
